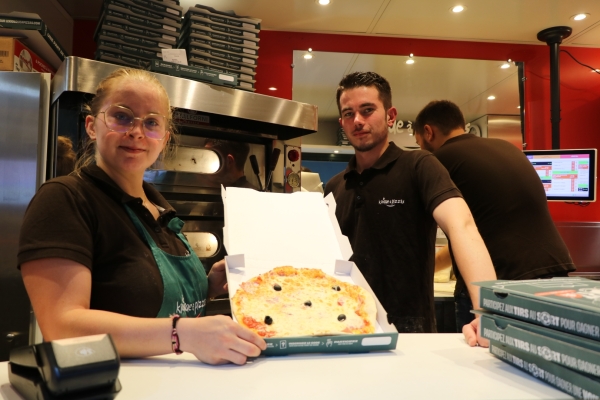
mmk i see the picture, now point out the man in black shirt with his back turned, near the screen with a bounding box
[413,100,575,327]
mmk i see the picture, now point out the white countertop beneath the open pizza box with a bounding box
[0,334,571,400]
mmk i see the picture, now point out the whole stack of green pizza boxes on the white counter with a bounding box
[477,277,600,399]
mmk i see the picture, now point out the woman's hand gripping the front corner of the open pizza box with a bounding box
[177,316,267,365]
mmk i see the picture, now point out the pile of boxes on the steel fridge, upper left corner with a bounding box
[0,12,67,76]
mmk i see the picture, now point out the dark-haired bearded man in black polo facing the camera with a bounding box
[325,72,496,345]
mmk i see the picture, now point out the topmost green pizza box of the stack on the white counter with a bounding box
[475,277,600,340]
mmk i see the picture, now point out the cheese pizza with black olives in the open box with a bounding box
[231,266,377,338]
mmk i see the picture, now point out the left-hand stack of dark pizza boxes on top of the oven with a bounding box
[94,0,183,68]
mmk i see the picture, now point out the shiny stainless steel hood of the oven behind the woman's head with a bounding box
[51,57,317,140]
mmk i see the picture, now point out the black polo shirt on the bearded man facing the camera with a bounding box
[325,142,461,332]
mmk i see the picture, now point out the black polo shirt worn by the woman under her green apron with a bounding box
[17,165,187,317]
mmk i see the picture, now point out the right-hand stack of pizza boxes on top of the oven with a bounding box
[177,4,261,92]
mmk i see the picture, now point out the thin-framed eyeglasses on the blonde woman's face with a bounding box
[98,104,167,140]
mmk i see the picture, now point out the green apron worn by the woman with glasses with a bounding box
[125,206,208,318]
